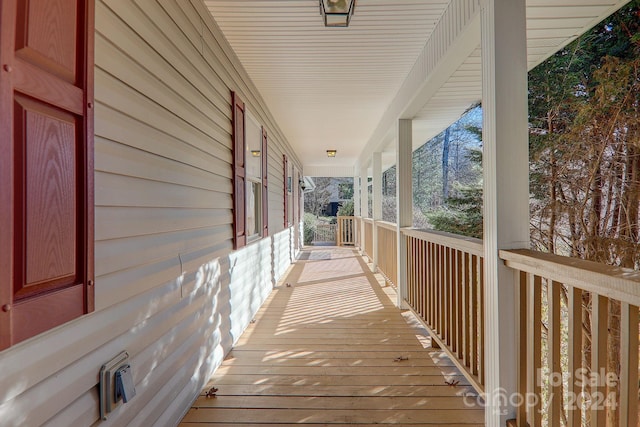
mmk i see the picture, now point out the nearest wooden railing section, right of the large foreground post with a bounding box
[500,250,640,427]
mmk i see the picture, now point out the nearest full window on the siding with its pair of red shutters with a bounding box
[232,92,269,249]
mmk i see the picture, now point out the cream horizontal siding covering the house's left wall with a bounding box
[0,0,297,426]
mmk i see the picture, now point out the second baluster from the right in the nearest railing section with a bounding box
[591,294,609,427]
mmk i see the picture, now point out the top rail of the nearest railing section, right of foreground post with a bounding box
[500,249,640,306]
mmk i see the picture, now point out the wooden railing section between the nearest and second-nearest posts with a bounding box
[402,229,484,392]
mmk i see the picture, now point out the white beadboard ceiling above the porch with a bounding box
[204,0,628,176]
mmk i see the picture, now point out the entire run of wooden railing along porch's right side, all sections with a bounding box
[356,218,640,427]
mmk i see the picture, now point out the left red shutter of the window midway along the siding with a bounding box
[231,92,247,249]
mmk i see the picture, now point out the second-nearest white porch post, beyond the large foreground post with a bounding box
[396,119,413,308]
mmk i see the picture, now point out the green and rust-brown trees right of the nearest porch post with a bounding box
[529,0,640,425]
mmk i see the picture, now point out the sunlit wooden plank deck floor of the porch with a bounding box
[180,247,484,427]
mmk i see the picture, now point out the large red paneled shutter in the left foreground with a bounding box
[0,0,94,349]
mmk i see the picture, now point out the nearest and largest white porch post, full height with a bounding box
[481,0,529,427]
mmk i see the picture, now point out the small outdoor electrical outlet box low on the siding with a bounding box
[99,351,136,420]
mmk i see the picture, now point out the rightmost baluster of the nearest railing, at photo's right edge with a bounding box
[619,303,638,426]
